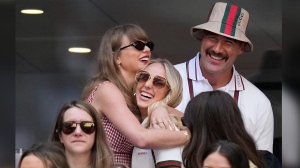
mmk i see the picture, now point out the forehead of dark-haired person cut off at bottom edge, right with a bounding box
[203,152,231,168]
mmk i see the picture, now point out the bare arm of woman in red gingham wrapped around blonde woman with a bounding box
[92,82,189,148]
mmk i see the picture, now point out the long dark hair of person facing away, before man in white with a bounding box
[182,90,264,168]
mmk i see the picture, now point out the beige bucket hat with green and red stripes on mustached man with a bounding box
[191,2,253,52]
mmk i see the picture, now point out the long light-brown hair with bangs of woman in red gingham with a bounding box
[82,24,148,118]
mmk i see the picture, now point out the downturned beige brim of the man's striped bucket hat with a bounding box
[191,22,253,52]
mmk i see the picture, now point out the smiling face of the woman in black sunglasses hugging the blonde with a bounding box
[117,35,151,74]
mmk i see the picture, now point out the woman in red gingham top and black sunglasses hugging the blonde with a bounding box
[83,24,189,167]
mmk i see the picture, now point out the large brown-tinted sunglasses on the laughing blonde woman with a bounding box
[135,70,169,89]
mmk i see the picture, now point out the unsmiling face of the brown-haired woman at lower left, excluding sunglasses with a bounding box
[60,107,95,154]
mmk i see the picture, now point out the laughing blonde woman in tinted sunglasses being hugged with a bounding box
[132,59,183,168]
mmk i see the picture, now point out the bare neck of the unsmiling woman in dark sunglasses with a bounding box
[66,151,91,168]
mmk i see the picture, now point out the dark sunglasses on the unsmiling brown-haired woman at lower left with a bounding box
[61,121,96,135]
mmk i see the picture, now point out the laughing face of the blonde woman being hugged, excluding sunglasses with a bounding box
[136,63,169,117]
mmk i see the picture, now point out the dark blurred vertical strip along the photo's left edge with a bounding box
[0,1,15,168]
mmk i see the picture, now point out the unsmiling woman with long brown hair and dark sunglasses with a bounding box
[50,100,114,168]
